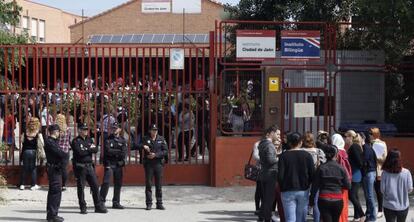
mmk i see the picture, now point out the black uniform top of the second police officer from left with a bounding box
[71,136,98,163]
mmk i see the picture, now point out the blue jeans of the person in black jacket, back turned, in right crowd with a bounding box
[282,190,309,222]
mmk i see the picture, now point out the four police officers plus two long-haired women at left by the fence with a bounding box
[19,114,167,222]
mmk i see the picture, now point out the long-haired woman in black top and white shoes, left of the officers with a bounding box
[20,117,45,190]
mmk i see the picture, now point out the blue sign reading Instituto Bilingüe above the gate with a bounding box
[281,30,321,60]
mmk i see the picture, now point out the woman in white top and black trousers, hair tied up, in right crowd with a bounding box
[368,127,387,218]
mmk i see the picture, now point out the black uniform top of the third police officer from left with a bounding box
[104,134,128,166]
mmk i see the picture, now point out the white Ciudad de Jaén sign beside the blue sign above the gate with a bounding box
[236,30,276,61]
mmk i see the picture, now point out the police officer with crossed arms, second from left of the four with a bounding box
[71,123,108,214]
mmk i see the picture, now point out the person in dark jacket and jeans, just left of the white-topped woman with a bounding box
[359,133,377,222]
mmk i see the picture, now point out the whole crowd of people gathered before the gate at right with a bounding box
[253,125,413,222]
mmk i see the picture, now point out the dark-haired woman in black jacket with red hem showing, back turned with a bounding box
[309,145,351,222]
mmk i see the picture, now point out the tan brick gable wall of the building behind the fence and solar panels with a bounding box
[71,0,223,42]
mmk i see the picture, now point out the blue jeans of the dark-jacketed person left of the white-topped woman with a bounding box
[363,171,377,221]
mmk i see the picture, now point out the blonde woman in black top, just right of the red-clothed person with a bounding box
[345,130,365,222]
